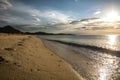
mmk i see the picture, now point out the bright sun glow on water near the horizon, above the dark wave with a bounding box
[108,35,117,49]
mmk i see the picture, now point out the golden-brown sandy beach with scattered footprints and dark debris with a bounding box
[0,34,82,80]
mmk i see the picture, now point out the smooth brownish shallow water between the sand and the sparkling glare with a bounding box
[42,40,96,80]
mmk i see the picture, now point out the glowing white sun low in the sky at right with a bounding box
[102,10,120,22]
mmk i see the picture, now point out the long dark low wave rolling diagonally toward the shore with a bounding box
[47,39,120,57]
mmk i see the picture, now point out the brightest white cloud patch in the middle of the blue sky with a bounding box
[30,9,69,22]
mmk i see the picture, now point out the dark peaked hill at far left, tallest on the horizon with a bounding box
[0,25,22,33]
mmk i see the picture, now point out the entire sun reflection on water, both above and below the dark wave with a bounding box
[98,35,118,80]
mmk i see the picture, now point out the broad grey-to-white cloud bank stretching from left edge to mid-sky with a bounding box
[0,0,70,26]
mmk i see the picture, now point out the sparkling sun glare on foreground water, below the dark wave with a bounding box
[98,55,117,80]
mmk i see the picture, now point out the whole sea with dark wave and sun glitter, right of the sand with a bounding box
[39,35,120,80]
